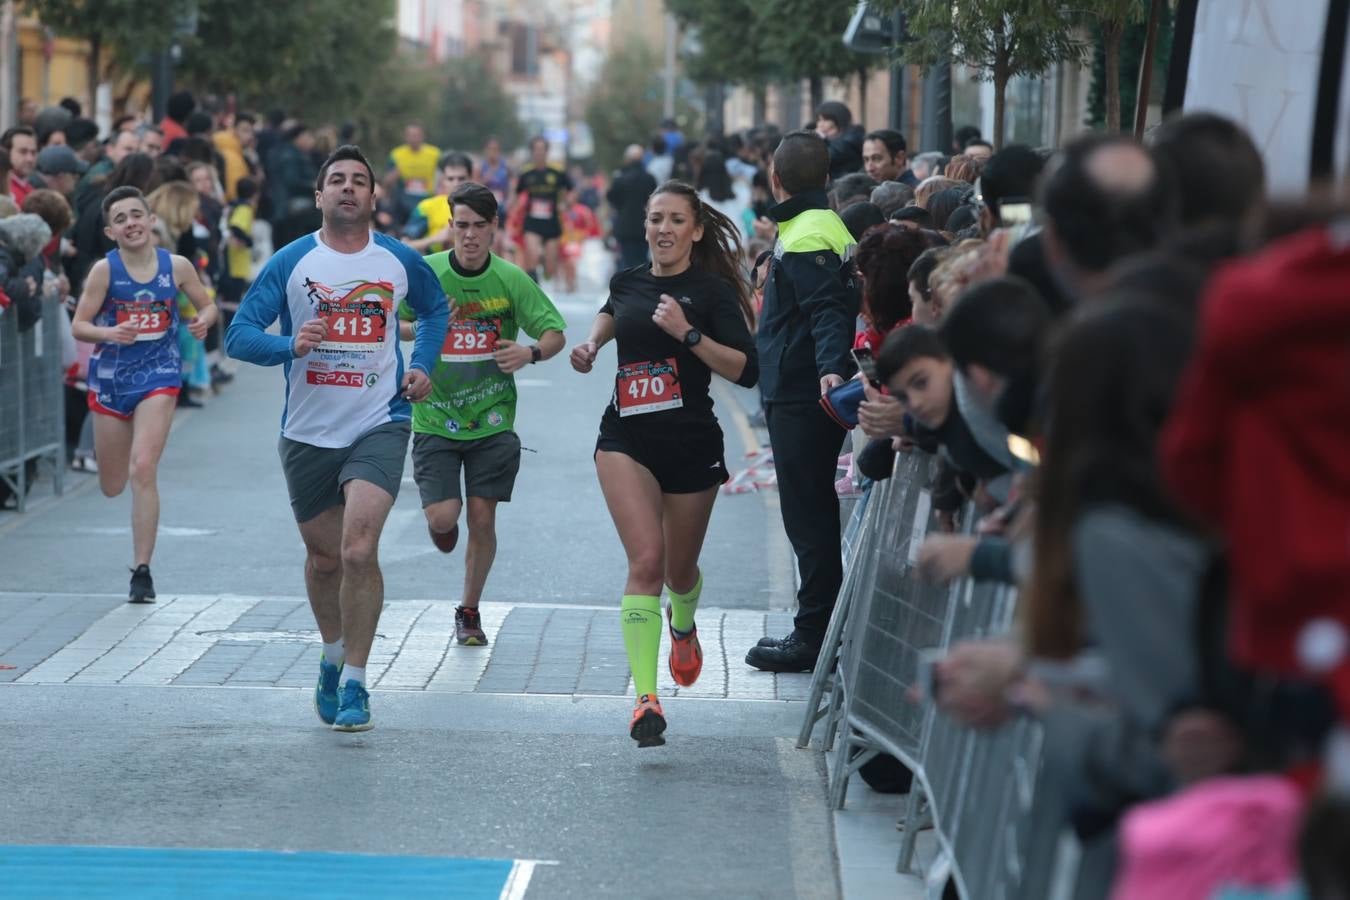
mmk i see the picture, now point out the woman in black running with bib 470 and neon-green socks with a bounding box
[571,181,759,748]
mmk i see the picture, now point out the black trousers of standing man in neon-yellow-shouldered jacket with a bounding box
[764,401,846,644]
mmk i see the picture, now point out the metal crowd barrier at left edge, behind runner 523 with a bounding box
[0,300,66,513]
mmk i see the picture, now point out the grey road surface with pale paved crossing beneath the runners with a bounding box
[0,261,838,899]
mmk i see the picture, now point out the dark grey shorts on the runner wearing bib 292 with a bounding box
[413,432,520,507]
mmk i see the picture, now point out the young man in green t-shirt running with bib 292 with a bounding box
[398,182,567,645]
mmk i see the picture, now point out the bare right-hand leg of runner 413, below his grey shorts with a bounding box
[339,478,394,669]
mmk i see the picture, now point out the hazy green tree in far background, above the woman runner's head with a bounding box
[586,40,697,169]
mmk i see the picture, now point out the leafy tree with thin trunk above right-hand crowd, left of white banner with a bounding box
[891,0,1087,147]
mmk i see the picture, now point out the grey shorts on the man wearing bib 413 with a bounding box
[277,422,412,522]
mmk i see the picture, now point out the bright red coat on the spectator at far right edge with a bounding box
[1161,221,1350,716]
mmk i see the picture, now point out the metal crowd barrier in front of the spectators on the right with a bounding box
[798,452,1058,900]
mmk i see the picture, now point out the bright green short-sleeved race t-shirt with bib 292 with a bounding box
[398,250,567,440]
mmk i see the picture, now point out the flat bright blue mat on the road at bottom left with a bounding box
[0,845,513,900]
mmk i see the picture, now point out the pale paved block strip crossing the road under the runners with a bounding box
[0,595,810,700]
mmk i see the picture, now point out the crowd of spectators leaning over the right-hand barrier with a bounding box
[783,97,1350,897]
